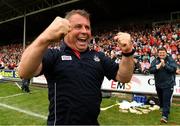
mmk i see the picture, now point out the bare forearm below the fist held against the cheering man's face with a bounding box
[18,34,49,78]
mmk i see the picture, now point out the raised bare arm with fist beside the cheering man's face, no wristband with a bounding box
[18,17,70,78]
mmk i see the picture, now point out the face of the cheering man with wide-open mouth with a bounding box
[65,14,91,52]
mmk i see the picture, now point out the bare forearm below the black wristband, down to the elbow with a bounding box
[116,56,134,83]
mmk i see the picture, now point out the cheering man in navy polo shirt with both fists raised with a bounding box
[18,10,134,125]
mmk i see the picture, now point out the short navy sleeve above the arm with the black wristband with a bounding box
[100,53,119,80]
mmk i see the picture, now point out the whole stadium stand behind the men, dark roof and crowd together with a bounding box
[0,0,180,73]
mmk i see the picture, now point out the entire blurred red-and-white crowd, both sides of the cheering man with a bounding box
[0,23,180,74]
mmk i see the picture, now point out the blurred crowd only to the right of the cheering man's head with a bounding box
[92,23,180,74]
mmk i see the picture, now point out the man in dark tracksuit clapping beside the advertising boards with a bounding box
[150,47,177,123]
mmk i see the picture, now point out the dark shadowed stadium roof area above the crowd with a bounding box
[0,0,179,44]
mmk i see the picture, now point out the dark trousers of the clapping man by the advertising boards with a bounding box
[156,87,174,118]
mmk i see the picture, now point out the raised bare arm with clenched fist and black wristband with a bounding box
[115,32,135,83]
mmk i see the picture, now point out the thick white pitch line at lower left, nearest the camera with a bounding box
[0,103,47,120]
